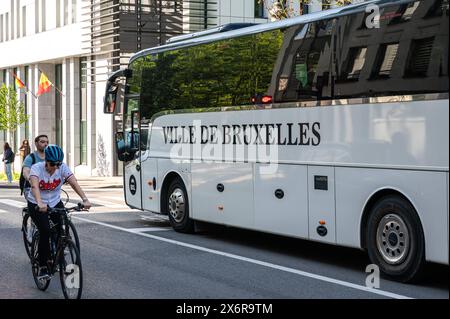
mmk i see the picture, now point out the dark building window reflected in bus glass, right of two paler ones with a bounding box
[405,37,434,77]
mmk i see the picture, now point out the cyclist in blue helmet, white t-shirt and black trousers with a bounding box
[27,144,91,276]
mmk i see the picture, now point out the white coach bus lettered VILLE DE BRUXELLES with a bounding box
[104,0,449,282]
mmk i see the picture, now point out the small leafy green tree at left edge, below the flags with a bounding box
[0,84,28,145]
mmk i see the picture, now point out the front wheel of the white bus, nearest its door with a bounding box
[165,178,194,233]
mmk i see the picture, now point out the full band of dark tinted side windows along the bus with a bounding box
[135,0,448,115]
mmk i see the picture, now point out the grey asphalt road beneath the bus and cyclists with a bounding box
[0,189,449,301]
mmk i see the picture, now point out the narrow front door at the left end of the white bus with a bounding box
[123,97,142,209]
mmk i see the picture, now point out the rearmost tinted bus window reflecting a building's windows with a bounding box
[332,1,448,98]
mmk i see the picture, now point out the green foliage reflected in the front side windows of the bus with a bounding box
[137,30,283,118]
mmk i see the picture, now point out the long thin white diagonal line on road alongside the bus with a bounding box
[74,217,412,299]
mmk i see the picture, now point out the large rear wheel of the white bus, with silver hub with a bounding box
[366,195,425,282]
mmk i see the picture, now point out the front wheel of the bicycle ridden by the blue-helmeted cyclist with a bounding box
[59,239,83,299]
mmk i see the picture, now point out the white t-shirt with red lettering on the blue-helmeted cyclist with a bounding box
[28,162,73,207]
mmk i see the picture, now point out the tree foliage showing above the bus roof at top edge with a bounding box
[258,0,352,21]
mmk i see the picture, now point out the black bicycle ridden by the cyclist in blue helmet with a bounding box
[31,203,85,299]
